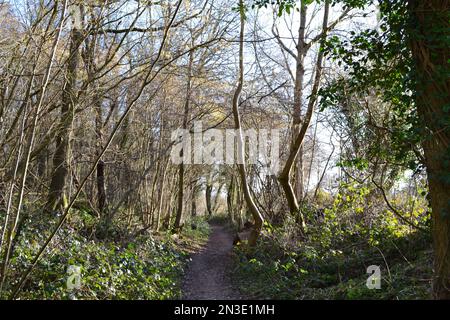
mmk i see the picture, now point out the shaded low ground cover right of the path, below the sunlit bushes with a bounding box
[233,219,432,299]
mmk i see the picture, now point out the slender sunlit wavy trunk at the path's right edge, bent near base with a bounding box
[233,0,264,246]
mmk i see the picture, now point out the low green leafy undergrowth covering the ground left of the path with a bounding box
[1,212,209,300]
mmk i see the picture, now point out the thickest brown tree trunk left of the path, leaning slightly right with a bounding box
[45,22,83,212]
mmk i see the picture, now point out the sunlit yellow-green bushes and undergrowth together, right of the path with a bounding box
[235,172,432,299]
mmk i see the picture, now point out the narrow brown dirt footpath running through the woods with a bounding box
[183,223,242,300]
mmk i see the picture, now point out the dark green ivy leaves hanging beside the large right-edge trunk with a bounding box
[319,1,434,175]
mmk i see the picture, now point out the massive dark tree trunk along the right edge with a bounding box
[408,0,450,299]
